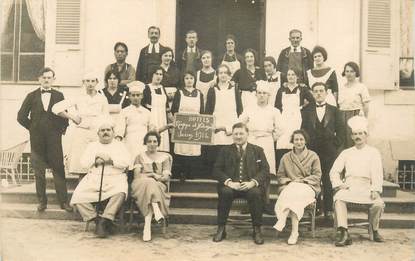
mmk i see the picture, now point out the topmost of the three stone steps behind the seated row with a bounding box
[47,175,399,197]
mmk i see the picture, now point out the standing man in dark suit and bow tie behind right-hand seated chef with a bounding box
[301,82,345,217]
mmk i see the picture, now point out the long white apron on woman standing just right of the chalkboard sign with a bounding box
[213,88,238,145]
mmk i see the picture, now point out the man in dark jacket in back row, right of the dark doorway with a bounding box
[277,29,314,83]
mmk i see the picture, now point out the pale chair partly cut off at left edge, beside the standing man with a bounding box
[0,140,29,184]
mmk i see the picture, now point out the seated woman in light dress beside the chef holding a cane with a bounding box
[131,131,172,242]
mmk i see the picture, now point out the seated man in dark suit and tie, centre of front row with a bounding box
[213,123,269,244]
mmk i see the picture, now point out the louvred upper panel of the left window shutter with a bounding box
[55,0,81,45]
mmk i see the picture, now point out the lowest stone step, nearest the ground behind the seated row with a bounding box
[1,203,415,226]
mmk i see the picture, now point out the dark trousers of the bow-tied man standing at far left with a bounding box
[30,126,68,204]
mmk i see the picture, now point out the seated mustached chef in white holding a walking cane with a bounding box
[71,116,131,238]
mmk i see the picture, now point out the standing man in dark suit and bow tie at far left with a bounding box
[17,68,76,212]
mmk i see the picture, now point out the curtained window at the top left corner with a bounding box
[1,0,45,82]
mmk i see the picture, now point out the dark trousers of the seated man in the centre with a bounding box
[218,185,264,226]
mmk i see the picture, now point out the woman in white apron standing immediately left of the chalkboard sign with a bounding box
[141,67,171,152]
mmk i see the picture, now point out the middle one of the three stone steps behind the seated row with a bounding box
[1,184,415,213]
